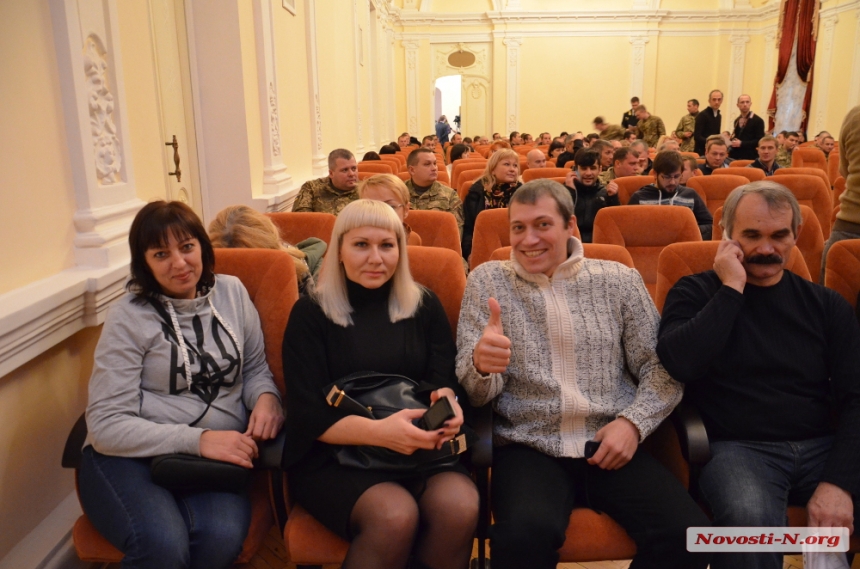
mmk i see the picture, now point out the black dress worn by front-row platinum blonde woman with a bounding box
[283,281,466,539]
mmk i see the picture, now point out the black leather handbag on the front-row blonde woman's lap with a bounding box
[325,372,468,472]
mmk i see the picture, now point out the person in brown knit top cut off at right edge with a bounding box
[820,105,860,282]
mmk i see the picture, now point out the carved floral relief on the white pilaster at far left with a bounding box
[84,35,122,186]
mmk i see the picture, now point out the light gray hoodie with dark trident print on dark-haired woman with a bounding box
[85,275,280,457]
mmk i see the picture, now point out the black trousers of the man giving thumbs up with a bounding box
[490,445,711,569]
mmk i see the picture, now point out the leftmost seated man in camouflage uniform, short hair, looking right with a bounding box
[293,148,360,215]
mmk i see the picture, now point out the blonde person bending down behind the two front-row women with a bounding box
[209,205,326,293]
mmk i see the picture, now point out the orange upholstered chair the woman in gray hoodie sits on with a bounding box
[62,249,299,563]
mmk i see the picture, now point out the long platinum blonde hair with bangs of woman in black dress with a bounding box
[314,199,423,327]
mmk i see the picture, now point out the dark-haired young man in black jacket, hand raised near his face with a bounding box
[564,148,621,243]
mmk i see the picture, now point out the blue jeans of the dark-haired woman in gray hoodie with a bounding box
[79,446,251,569]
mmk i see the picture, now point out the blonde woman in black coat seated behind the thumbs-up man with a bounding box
[462,148,522,261]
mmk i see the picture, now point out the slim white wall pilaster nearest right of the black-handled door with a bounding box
[254,0,292,200]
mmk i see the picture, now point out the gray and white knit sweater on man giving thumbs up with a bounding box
[457,238,682,458]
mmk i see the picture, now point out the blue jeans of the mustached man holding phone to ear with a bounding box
[699,437,833,569]
